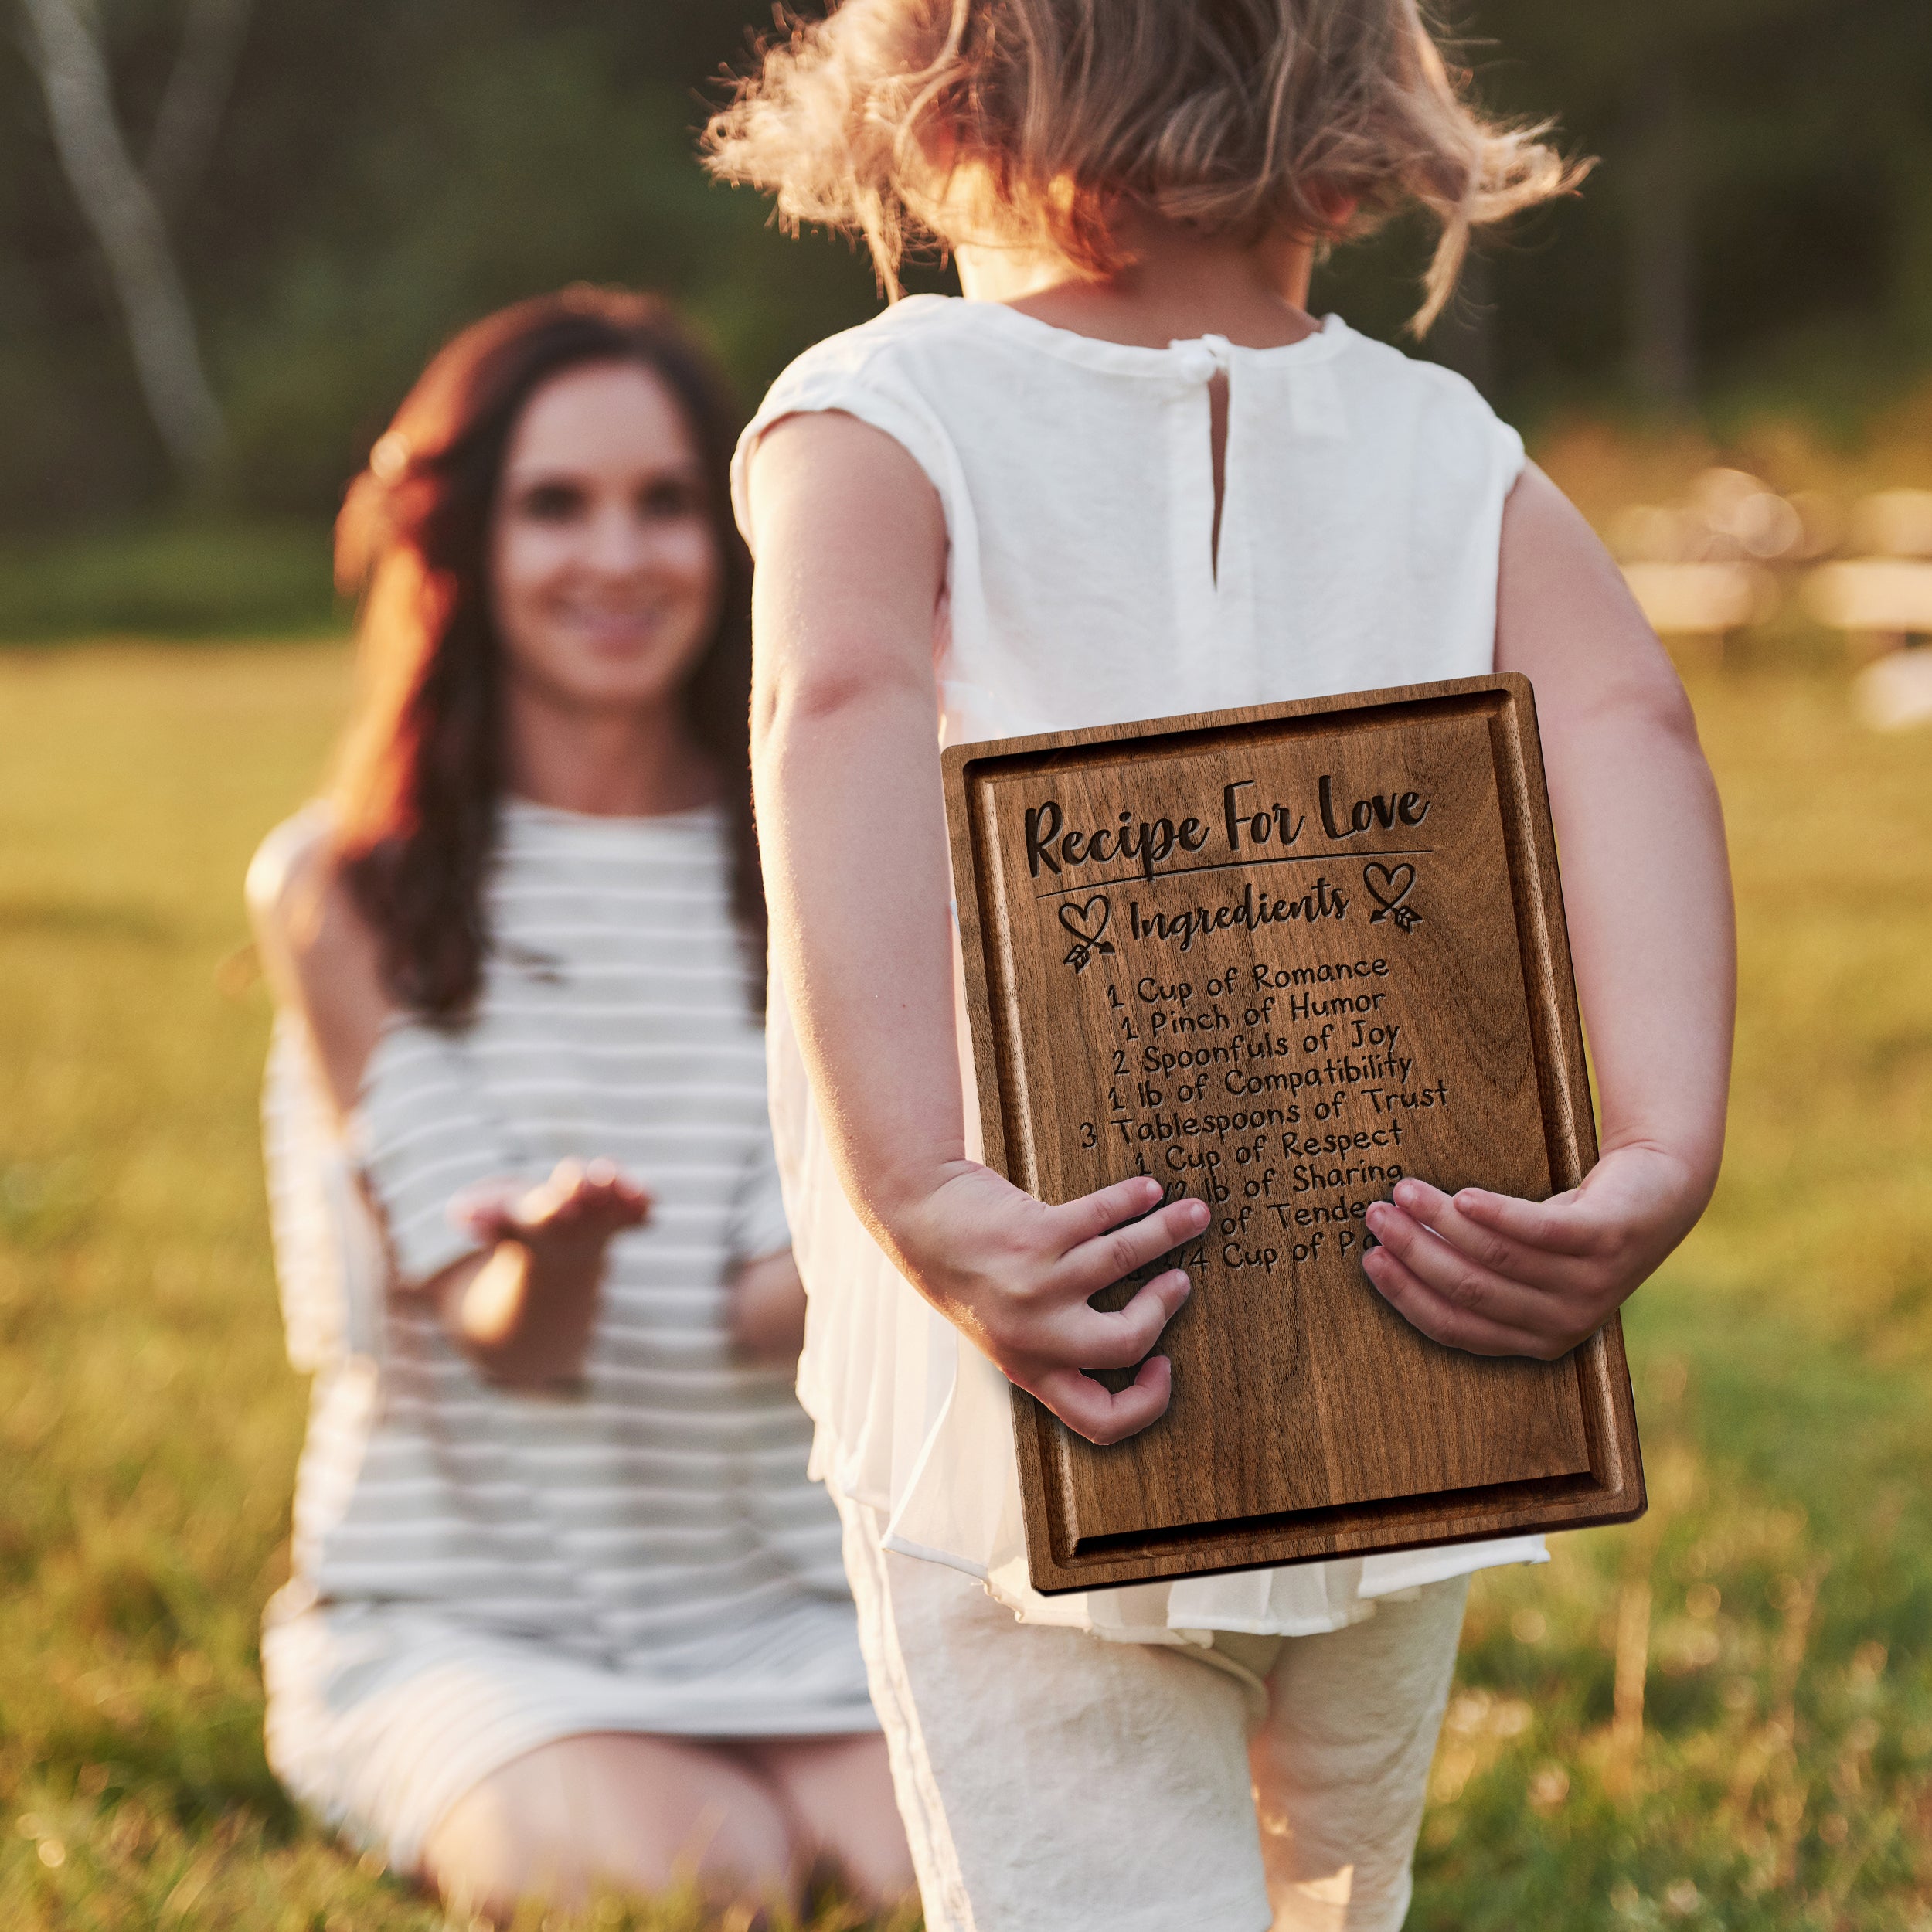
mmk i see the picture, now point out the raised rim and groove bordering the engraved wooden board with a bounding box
[941,671,1646,1596]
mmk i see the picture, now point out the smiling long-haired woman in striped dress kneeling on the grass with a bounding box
[250,290,910,1909]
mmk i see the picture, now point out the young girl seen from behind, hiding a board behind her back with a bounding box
[711,0,1731,1932]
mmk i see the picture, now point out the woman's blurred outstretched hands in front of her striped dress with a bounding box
[433,1162,651,1389]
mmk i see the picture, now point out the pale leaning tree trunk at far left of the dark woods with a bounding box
[23,0,223,479]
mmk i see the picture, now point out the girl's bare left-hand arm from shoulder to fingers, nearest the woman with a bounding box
[750,413,1208,1441]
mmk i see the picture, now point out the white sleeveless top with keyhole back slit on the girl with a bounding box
[733,296,1544,1642]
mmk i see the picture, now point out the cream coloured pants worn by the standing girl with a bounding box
[838,1499,1468,1932]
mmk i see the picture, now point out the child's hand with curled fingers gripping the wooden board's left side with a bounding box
[893,1162,1208,1444]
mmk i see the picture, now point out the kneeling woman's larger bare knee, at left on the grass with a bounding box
[421,1731,796,1915]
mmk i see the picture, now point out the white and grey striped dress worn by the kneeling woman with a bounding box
[263,800,876,1869]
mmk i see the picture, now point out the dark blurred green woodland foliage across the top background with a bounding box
[11,0,1932,636]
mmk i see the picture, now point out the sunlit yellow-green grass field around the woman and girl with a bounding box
[0,645,1932,1932]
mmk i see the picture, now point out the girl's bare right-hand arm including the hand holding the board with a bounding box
[1364,470,1737,1359]
